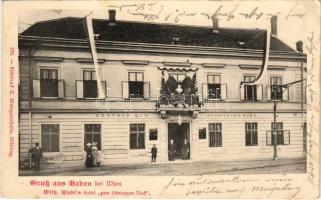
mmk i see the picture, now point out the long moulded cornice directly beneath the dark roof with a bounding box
[19,36,306,61]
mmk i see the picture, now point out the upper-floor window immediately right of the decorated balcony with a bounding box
[207,75,221,99]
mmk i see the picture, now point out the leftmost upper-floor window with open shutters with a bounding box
[40,69,58,97]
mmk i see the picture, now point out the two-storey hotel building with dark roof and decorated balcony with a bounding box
[19,11,306,164]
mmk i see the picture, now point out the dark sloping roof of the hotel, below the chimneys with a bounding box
[20,17,296,52]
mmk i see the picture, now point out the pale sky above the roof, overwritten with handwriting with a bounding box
[18,0,307,49]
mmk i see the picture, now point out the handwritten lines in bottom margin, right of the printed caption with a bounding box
[161,175,301,198]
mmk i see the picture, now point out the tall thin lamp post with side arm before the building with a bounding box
[272,79,306,160]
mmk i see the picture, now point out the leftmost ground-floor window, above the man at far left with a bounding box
[41,124,59,152]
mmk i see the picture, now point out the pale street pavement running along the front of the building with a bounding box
[19,158,306,176]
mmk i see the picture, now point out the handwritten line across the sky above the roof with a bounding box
[108,2,306,23]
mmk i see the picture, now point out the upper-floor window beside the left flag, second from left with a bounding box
[83,70,98,98]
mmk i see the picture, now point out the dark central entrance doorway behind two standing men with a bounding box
[168,123,190,159]
